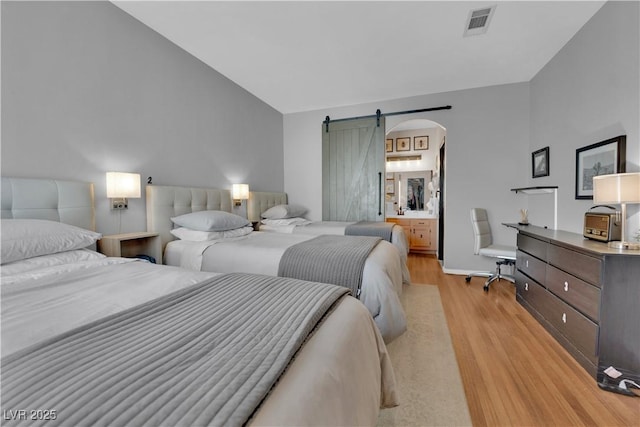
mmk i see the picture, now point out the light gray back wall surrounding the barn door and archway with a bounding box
[284,83,529,272]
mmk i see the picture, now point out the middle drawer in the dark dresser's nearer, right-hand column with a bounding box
[545,265,600,322]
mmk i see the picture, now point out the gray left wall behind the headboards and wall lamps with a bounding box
[2,1,284,234]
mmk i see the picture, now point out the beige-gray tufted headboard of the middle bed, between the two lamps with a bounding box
[147,185,232,251]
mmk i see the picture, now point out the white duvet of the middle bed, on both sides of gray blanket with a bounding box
[164,232,407,343]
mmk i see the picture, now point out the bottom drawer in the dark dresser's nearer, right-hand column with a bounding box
[537,292,598,364]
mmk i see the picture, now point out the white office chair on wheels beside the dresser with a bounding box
[465,208,516,292]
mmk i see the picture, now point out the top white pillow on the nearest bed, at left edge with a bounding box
[1,219,102,264]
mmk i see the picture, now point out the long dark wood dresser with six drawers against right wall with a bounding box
[510,225,640,392]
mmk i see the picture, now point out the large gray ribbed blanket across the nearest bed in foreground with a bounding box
[2,274,348,426]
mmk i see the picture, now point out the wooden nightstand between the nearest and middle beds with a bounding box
[98,231,162,264]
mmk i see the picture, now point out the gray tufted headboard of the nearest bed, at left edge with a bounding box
[1,177,96,231]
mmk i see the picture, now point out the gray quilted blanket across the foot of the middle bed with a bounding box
[278,235,381,298]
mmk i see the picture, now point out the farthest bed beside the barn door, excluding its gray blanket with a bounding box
[247,191,411,285]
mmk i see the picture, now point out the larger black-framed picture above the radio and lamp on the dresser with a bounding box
[576,135,627,199]
